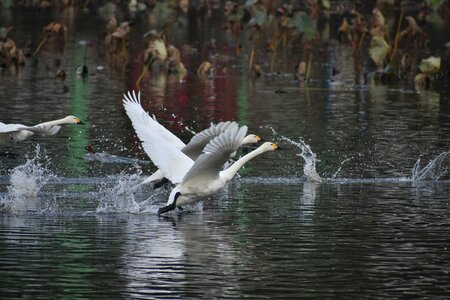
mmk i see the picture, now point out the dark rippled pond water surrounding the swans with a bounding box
[0,3,450,299]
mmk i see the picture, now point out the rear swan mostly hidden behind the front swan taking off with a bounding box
[123,91,261,184]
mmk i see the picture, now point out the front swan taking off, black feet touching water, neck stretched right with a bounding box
[130,117,279,214]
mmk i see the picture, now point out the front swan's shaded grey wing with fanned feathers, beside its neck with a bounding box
[183,126,248,182]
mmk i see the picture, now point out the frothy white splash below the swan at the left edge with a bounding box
[0,145,56,213]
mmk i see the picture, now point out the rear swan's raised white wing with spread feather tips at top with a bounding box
[123,91,185,149]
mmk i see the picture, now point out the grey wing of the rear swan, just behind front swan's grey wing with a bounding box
[181,121,238,160]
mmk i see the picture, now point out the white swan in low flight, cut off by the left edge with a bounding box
[0,116,84,144]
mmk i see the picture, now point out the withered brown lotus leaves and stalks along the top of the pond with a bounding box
[0,0,450,89]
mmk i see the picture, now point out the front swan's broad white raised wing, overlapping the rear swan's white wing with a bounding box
[133,111,194,184]
